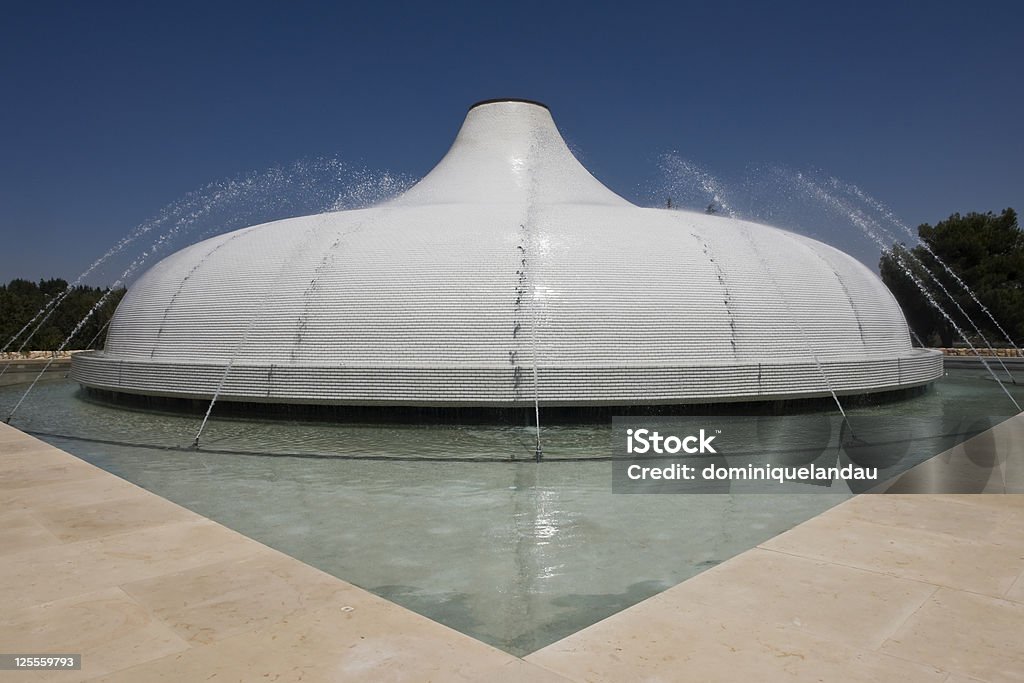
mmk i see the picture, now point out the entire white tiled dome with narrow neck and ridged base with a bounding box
[72,100,942,407]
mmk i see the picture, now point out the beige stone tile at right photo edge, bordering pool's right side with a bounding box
[761,510,1024,597]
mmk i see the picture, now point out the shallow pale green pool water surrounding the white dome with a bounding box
[0,371,1009,654]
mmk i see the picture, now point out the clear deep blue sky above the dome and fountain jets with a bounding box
[0,1,1024,282]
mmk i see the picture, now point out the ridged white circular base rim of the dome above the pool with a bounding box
[71,349,942,408]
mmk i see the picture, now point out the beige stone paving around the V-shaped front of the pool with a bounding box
[0,416,1024,683]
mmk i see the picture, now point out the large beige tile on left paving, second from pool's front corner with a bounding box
[122,552,369,644]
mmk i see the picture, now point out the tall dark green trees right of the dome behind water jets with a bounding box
[879,209,1024,346]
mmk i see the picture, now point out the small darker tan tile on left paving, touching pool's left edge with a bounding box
[34,495,197,543]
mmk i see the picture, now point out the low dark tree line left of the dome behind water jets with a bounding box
[0,279,125,351]
